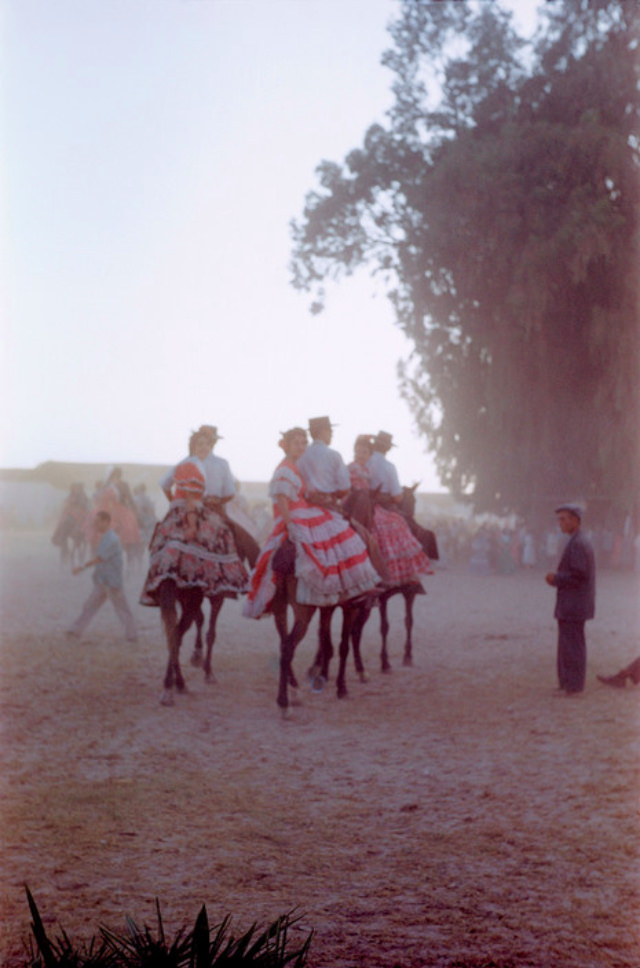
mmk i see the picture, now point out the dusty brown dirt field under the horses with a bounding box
[0,533,640,968]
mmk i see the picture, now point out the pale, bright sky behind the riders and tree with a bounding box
[0,0,531,490]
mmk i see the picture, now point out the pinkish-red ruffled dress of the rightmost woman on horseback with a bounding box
[347,461,434,585]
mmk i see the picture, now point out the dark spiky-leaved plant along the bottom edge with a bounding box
[25,887,313,968]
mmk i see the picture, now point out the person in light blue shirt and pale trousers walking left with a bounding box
[67,511,138,642]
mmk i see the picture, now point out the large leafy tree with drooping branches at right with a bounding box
[292,0,640,513]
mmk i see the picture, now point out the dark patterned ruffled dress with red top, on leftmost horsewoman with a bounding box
[140,458,248,606]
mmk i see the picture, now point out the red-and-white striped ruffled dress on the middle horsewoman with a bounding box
[242,459,380,618]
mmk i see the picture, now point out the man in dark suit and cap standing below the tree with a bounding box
[545,504,596,696]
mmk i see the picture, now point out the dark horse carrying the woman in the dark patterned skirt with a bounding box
[158,516,260,706]
